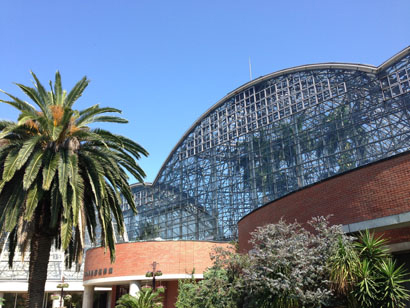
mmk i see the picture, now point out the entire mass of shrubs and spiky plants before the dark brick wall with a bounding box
[176,218,409,308]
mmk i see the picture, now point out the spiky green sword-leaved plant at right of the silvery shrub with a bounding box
[329,230,410,307]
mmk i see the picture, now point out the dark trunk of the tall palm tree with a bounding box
[26,232,53,308]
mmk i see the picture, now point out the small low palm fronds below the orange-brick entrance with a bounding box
[115,288,164,308]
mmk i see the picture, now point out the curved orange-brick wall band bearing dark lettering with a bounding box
[84,241,230,281]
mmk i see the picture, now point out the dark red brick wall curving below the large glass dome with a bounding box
[238,153,410,251]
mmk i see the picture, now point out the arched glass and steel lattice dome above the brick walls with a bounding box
[124,48,410,240]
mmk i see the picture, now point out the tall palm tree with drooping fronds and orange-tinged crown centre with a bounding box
[0,72,148,308]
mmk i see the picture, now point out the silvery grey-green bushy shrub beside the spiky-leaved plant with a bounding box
[243,218,345,307]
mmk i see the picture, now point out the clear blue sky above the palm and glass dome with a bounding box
[0,0,410,182]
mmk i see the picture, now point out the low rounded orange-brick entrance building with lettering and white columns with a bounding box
[83,240,231,308]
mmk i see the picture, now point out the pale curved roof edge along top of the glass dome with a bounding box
[152,46,410,185]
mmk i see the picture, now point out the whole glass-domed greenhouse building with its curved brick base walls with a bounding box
[84,47,410,308]
